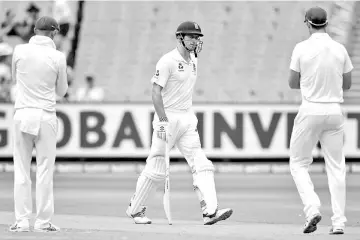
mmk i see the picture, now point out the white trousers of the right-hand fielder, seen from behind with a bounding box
[290,110,346,227]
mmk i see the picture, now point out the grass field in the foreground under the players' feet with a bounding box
[0,173,360,240]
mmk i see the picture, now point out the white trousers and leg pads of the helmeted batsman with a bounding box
[130,109,218,214]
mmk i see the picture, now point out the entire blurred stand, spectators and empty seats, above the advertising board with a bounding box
[0,0,360,103]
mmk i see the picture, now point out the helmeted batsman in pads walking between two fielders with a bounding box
[126,22,233,225]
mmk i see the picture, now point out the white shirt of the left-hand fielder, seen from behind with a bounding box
[12,36,68,112]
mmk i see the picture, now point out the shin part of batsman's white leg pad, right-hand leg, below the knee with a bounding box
[194,171,218,215]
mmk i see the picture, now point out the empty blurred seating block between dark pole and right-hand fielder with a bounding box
[75,1,340,103]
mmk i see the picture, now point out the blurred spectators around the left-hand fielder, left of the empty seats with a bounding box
[0,0,104,102]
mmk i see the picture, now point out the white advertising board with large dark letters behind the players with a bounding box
[0,104,360,158]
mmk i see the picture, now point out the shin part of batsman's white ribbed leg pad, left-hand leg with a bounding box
[130,175,155,214]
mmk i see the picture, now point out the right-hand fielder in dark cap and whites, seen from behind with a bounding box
[289,7,353,234]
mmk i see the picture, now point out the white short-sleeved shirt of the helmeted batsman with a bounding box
[151,48,197,110]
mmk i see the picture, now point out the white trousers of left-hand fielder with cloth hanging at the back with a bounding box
[13,108,57,227]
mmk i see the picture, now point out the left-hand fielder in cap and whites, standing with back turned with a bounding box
[9,17,68,232]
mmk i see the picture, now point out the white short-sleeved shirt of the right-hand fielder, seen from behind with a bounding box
[290,33,353,103]
